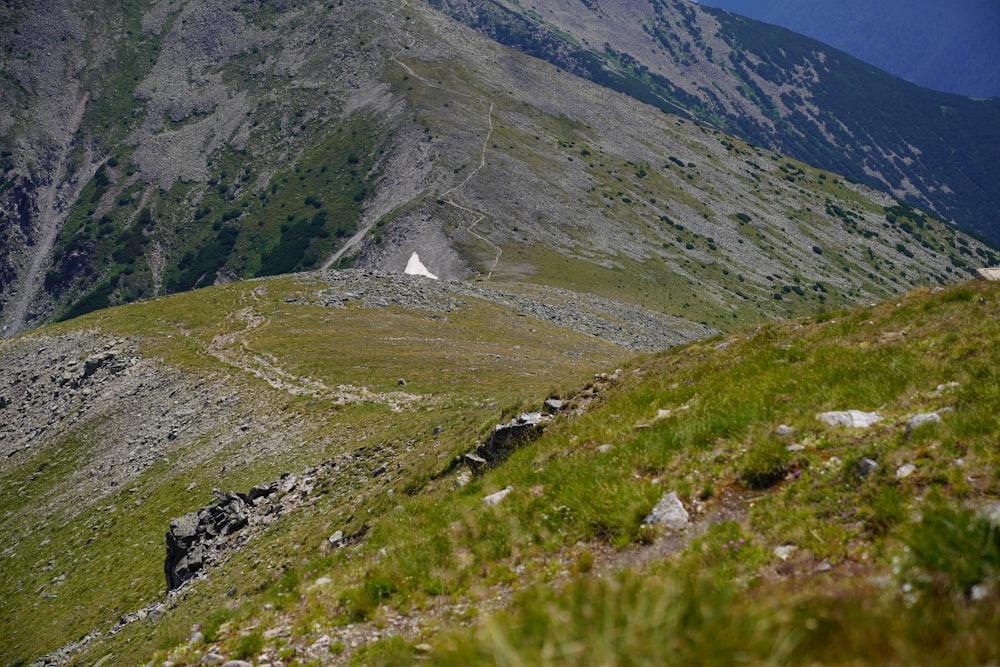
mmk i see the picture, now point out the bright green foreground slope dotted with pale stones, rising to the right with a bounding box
[78,283,1000,665]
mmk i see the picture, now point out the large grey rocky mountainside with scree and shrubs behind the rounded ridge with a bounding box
[0,0,995,333]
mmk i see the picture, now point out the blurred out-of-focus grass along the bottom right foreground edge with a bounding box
[433,572,1000,666]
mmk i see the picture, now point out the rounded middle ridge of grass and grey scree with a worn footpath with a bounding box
[0,273,664,664]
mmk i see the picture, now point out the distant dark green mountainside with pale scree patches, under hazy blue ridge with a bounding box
[442,0,1000,242]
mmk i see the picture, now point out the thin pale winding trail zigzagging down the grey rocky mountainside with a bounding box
[320,1,503,280]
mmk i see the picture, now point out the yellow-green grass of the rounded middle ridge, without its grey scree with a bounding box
[0,278,625,664]
